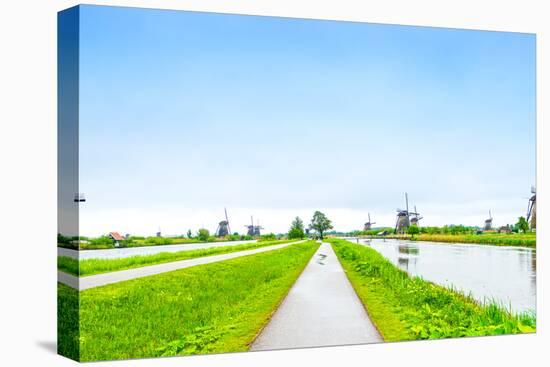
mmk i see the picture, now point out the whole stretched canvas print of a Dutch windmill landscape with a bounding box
[57,5,536,361]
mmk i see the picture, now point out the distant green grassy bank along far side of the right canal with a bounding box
[372,233,537,247]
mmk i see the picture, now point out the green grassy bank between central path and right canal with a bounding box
[327,239,536,341]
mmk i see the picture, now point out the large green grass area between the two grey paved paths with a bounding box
[60,241,318,361]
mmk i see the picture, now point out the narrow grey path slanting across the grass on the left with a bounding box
[57,241,304,291]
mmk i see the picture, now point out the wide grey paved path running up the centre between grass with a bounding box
[250,243,383,351]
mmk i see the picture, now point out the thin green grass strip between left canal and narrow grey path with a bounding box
[57,240,295,276]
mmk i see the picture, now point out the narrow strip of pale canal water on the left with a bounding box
[57,240,256,260]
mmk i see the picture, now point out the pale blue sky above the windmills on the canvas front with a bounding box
[70,6,536,236]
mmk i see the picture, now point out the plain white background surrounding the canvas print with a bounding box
[0,0,550,367]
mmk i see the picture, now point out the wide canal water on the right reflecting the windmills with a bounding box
[356,239,537,313]
